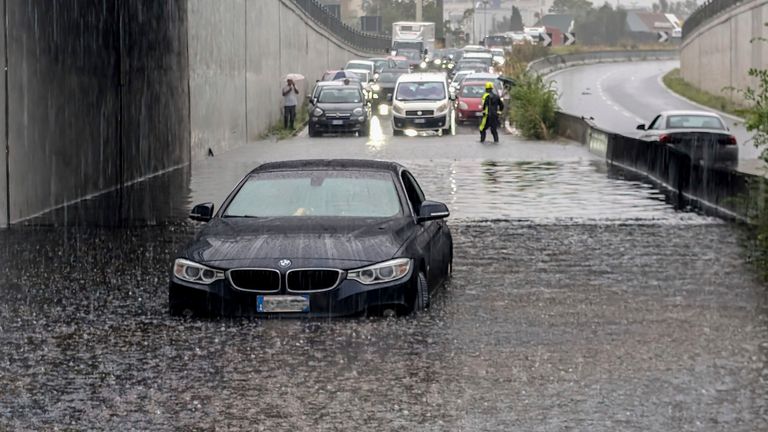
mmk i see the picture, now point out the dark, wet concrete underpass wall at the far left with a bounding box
[0,0,189,223]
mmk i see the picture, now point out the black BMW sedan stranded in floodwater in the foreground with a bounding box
[169,160,453,316]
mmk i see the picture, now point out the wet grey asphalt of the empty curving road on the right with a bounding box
[550,61,759,160]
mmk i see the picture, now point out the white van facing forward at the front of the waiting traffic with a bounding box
[392,73,453,136]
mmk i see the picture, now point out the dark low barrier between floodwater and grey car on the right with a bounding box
[557,112,768,221]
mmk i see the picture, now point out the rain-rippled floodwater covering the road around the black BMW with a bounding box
[0,116,768,431]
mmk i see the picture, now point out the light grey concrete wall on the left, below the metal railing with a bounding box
[188,0,375,159]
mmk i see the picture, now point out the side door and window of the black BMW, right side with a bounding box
[401,171,448,289]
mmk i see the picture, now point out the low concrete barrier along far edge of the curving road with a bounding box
[528,49,678,75]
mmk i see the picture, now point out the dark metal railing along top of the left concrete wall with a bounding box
[291,0,391,52]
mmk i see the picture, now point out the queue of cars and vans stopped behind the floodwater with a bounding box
[308,46,506,137]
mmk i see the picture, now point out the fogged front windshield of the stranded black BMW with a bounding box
[224,171,401,218]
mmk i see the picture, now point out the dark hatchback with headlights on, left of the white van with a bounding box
[309,84,371,137]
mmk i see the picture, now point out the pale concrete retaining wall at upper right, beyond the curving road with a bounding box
[680,0,768,102]
